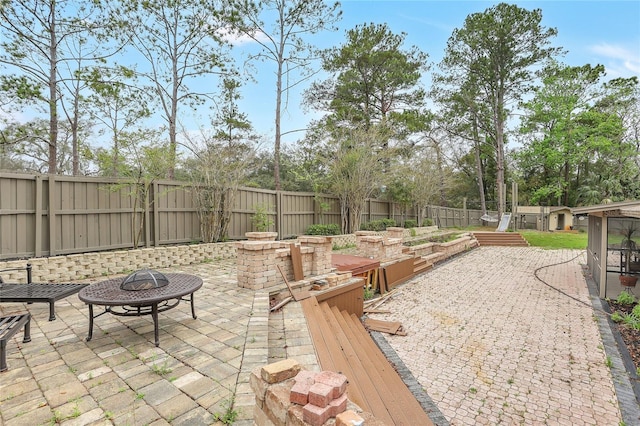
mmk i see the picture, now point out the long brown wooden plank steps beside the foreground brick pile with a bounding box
[301,297,433,426]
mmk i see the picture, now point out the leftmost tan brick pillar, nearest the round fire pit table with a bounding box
[236,241,280,290]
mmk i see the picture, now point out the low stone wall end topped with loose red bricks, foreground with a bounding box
[250,359,368,426]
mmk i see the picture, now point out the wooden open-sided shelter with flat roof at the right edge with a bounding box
[571,201,640,298]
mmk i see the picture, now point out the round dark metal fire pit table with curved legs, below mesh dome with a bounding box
[78,274,202,346]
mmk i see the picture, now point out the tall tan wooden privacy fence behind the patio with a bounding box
[0,173,496,260]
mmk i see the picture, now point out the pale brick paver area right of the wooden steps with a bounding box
[364,247,621,425]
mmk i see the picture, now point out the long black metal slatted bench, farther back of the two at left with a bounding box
[0,264,89,321]
